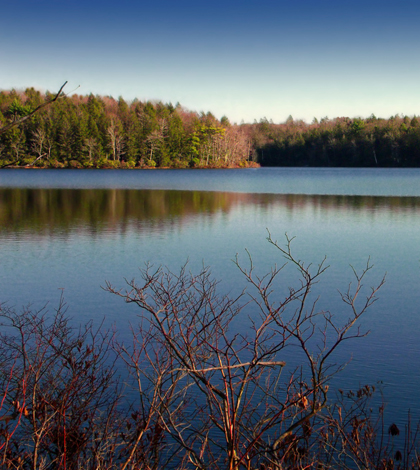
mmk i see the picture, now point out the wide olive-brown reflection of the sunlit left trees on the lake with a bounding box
[0,189,247,234]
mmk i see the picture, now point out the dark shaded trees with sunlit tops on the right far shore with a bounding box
[246,114,420,167]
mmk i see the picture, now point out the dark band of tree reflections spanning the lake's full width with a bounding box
[0,188,420,235]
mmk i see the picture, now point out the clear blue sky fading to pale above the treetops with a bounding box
[0,0,420,123]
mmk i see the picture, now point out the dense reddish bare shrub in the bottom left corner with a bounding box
[0,302,120,469]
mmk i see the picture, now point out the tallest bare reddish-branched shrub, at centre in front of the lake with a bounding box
[107,236,384,470]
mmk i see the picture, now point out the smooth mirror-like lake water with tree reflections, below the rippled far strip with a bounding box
[0,185,420,428]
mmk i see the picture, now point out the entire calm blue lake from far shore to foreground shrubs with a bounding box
[0,168,420,423]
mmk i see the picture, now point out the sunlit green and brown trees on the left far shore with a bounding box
[0,88,251,168]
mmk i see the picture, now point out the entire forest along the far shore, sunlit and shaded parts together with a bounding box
[0,88,420,168]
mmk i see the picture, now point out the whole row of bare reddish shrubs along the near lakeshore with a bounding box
[0,237,417,470]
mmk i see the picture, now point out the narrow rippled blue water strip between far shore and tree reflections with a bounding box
[0,168,420,196]
